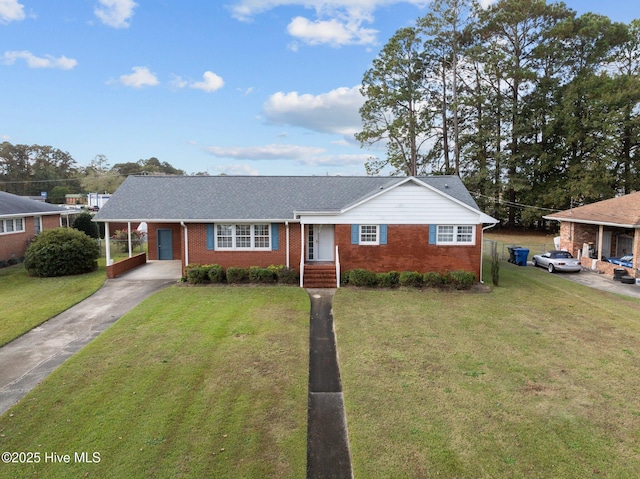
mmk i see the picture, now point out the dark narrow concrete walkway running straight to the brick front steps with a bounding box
[307,289,353,479]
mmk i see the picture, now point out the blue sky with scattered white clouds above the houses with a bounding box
[0,0,640,175]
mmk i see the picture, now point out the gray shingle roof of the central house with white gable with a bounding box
[95,176,478,221]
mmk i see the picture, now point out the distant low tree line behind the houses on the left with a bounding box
[0,141,185,204]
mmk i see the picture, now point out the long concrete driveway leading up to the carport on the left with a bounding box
[0,261,182,414]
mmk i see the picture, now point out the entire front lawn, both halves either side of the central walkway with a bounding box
[0,262,640,478]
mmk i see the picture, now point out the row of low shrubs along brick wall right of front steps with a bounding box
[340,269,478,289]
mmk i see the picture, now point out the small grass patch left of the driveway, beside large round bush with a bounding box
[0,260,107,346]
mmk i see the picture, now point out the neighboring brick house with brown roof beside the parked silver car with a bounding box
[544,192,640,278]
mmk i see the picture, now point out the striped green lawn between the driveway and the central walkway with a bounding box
[0,286,309,478]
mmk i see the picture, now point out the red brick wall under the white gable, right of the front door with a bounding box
[336,225,482,278]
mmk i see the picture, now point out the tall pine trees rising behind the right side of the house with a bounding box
[356,0,640,225]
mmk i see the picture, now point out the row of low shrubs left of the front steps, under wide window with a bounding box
[185,264,299,284]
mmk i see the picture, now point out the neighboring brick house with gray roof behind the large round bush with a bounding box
[0,191,69,261]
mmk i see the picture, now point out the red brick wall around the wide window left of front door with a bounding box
[184,223,300,270]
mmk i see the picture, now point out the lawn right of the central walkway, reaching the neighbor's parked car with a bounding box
[334,263,640,478]
